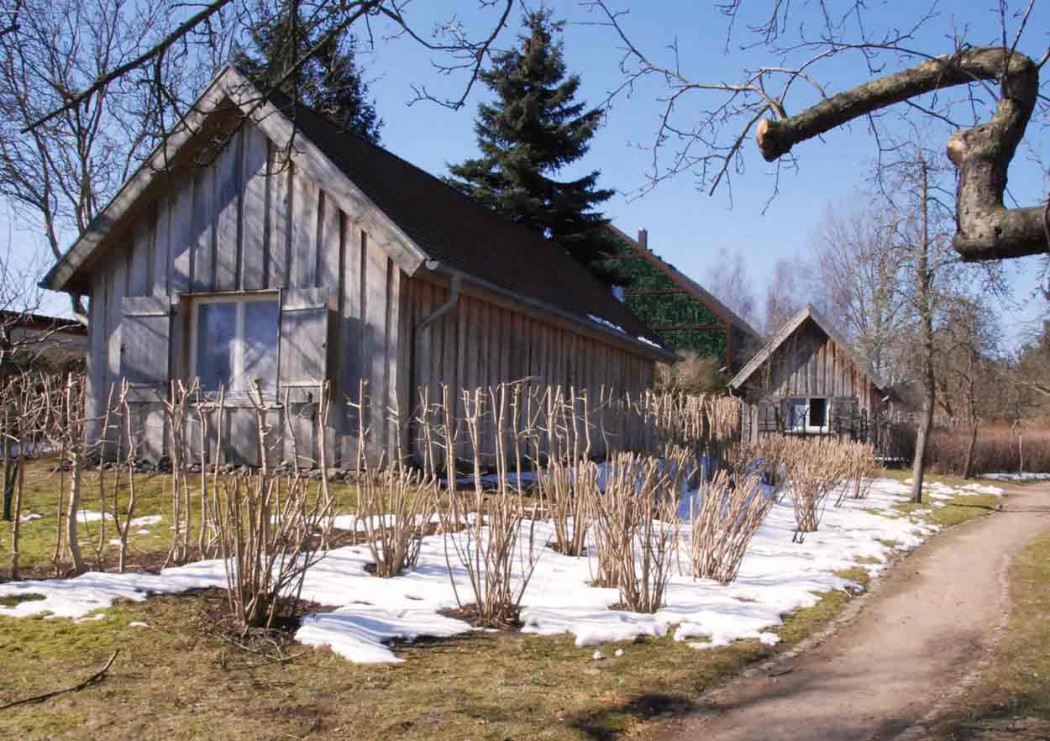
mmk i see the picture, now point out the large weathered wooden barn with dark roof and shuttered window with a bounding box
[42,67,671,465]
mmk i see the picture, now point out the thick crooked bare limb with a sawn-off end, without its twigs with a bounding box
[756,47,1050,260]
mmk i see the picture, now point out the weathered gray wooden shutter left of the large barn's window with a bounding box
[121,296,171,393]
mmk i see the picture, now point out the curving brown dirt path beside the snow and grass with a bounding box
[662,484,1050,741]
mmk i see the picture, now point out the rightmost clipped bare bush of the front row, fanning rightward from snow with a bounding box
[689,471,773,584]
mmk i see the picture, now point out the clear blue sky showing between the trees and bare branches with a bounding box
[6,0,1050,343]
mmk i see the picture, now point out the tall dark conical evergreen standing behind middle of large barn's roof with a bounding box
[449,10,614,282]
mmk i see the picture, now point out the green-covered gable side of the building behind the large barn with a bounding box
[607,227,762,375]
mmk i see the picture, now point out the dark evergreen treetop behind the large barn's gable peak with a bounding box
[234,0,382,143]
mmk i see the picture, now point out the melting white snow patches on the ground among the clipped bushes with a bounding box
[0,479,1002,662]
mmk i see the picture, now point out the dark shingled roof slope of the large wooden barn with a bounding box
[274,101,664,347]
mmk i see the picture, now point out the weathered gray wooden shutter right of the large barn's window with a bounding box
[277,288,330,396]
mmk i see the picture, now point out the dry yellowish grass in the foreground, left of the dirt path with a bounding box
[0,575,873,741]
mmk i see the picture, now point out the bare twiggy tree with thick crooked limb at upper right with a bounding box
[589,0,1050,265]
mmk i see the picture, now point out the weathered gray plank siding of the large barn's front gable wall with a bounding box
[87,119,400,464]
